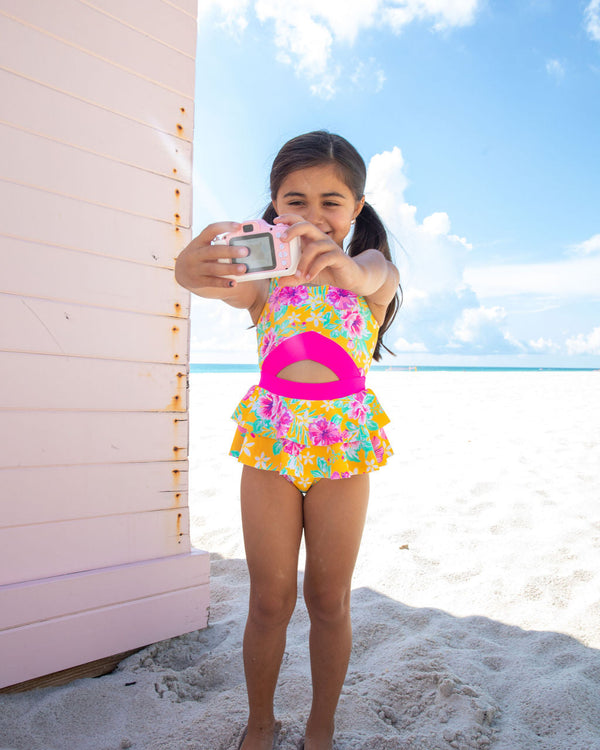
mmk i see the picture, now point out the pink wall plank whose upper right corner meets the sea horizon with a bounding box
[0,352,187,412]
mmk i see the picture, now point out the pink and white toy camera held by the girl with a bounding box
[212,219,300,281]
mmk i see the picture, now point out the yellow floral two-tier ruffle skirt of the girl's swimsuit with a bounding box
[230,386,392,492]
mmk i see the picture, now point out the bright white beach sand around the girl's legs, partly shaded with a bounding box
[0,372,600,750]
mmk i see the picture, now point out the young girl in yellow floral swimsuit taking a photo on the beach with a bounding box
[175,131,399,750]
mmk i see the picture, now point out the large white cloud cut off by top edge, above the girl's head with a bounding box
[204,0,482,99]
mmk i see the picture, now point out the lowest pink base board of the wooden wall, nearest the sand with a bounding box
[0,584,209,687]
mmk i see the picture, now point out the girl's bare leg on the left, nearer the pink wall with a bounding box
[241,466,303,750]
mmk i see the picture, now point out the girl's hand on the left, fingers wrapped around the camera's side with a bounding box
[175,221,248,297]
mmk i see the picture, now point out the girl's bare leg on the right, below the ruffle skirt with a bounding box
[304,474,369,750]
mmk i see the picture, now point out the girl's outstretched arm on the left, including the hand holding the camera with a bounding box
[175,221,268,318]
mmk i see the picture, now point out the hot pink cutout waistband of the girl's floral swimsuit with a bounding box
[259,331,365,401]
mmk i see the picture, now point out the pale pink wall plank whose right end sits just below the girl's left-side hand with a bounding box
[0,236,189,317]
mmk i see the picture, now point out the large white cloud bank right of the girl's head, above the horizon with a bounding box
[366,147,600,355]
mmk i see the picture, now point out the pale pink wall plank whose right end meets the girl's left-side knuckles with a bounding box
[0,181,191,269]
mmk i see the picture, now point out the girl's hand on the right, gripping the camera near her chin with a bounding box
[274,214,360,289]
